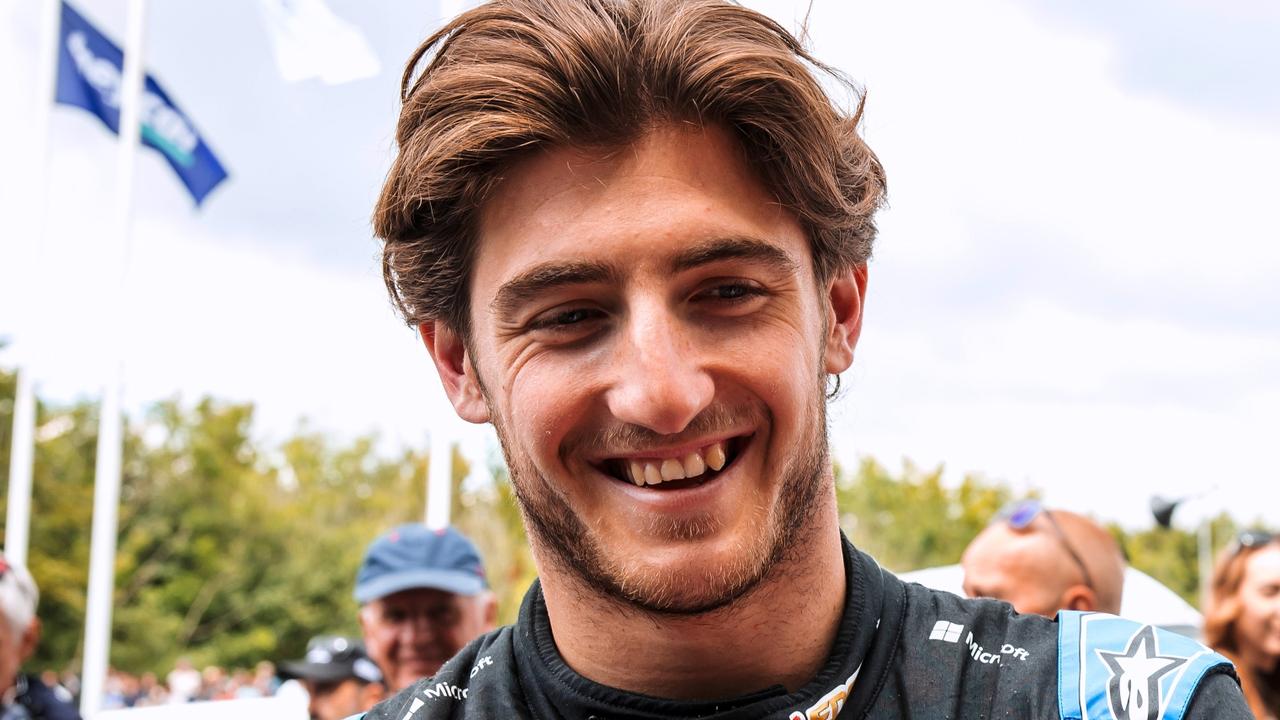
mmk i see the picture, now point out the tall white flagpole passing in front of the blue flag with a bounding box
[81,0,147,720]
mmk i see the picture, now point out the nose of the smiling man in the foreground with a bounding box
[607,302,716,434]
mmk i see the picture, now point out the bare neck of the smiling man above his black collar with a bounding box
[541,498,847,700]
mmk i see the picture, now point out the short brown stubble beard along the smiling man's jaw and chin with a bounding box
[490,379,829,616]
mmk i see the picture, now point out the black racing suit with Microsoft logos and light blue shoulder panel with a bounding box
[353,539,1251,720]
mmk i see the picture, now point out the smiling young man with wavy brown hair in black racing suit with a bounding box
[358,0,1247,720]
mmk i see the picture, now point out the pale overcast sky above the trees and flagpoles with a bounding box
[0,0,1280,527]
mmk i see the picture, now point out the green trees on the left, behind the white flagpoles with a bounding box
[0,375,429,673]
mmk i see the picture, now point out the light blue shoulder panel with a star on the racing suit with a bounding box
[1057,610,1230,720]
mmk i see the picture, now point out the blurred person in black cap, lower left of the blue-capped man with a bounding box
[280,635,387,720]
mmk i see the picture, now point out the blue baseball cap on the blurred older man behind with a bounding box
[355,523,485,605]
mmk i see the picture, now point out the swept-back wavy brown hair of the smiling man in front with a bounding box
[372,0,884,337]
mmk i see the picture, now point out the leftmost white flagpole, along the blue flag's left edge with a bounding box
[4,0,61,566]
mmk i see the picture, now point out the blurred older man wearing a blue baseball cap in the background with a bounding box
[355,524,498,693]
